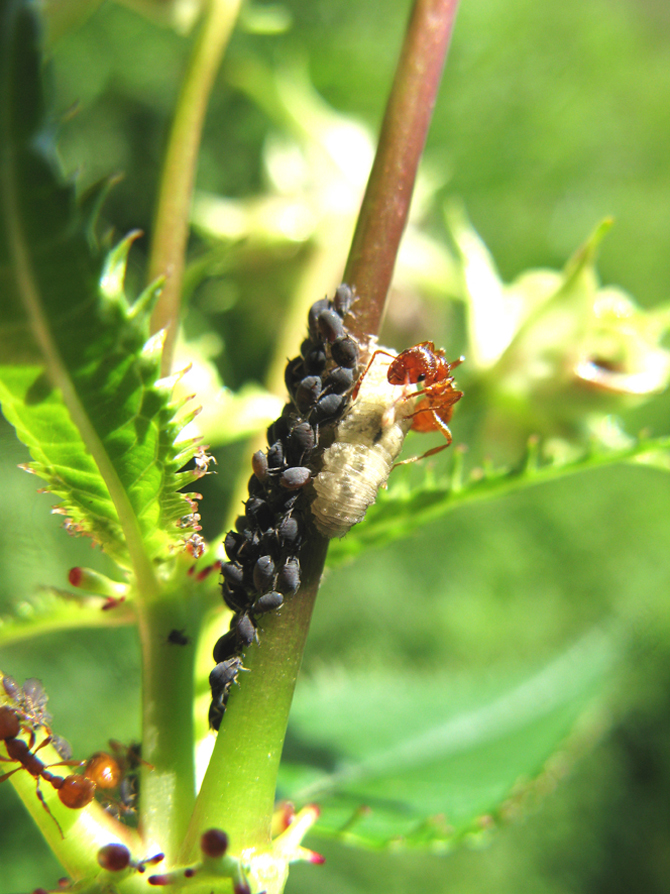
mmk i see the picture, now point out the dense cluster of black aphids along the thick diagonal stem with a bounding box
[209,285,359,730]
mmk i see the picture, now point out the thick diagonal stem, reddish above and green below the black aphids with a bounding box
[186,0,456,861]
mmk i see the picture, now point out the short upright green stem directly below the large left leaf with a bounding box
[139,585,202,866]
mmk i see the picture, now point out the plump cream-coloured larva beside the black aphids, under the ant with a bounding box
[312,348,415,537]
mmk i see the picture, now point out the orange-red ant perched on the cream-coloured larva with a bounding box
[352,341,465,459]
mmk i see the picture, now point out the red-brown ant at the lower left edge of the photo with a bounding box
[0,705,95,838]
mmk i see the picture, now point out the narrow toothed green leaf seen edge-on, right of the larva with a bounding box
[328,437,670,566]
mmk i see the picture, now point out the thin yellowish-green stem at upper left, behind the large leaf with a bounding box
[149,0,241,375]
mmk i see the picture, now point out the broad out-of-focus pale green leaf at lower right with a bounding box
[280,630,618,847]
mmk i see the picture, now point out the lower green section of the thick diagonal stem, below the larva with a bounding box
[182,535,328,861]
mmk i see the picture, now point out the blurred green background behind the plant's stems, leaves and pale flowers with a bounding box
[0,0,670,894]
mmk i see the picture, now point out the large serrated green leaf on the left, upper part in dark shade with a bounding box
[0,0,201,582]
